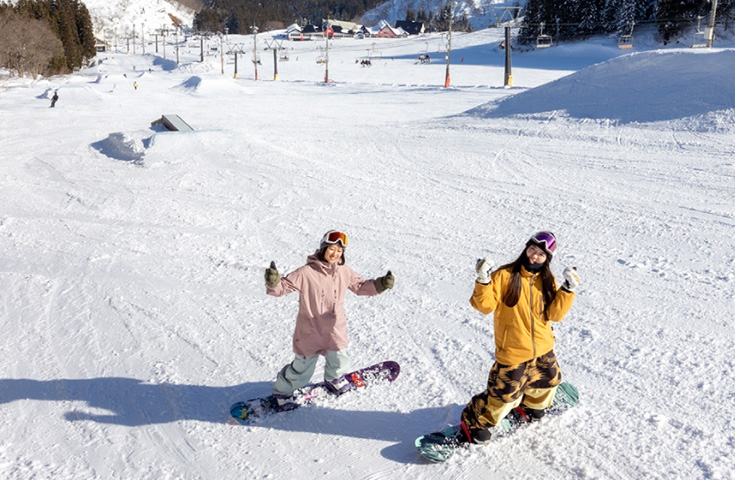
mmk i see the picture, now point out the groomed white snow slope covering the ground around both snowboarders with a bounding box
[0,30,735,480]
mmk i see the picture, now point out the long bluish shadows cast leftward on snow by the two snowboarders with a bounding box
[0,377,462,463]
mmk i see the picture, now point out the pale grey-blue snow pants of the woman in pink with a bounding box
[273,348,350,395]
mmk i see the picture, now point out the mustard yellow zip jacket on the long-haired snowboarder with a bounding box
[470,268,575,365]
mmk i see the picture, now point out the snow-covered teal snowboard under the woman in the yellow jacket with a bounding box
[415,382,579,462]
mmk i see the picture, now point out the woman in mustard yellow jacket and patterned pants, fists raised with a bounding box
[458,232,579,443]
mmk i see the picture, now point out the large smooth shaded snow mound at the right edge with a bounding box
[466,49,735,125]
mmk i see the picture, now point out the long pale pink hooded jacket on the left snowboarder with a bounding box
[265,254,378,357]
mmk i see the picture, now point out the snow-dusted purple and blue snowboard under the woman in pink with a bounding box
[230,361,401,425]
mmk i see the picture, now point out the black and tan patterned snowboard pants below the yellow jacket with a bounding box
[462,350,561,428]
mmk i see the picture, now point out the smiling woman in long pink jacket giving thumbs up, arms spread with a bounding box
[265,230,395,410]
